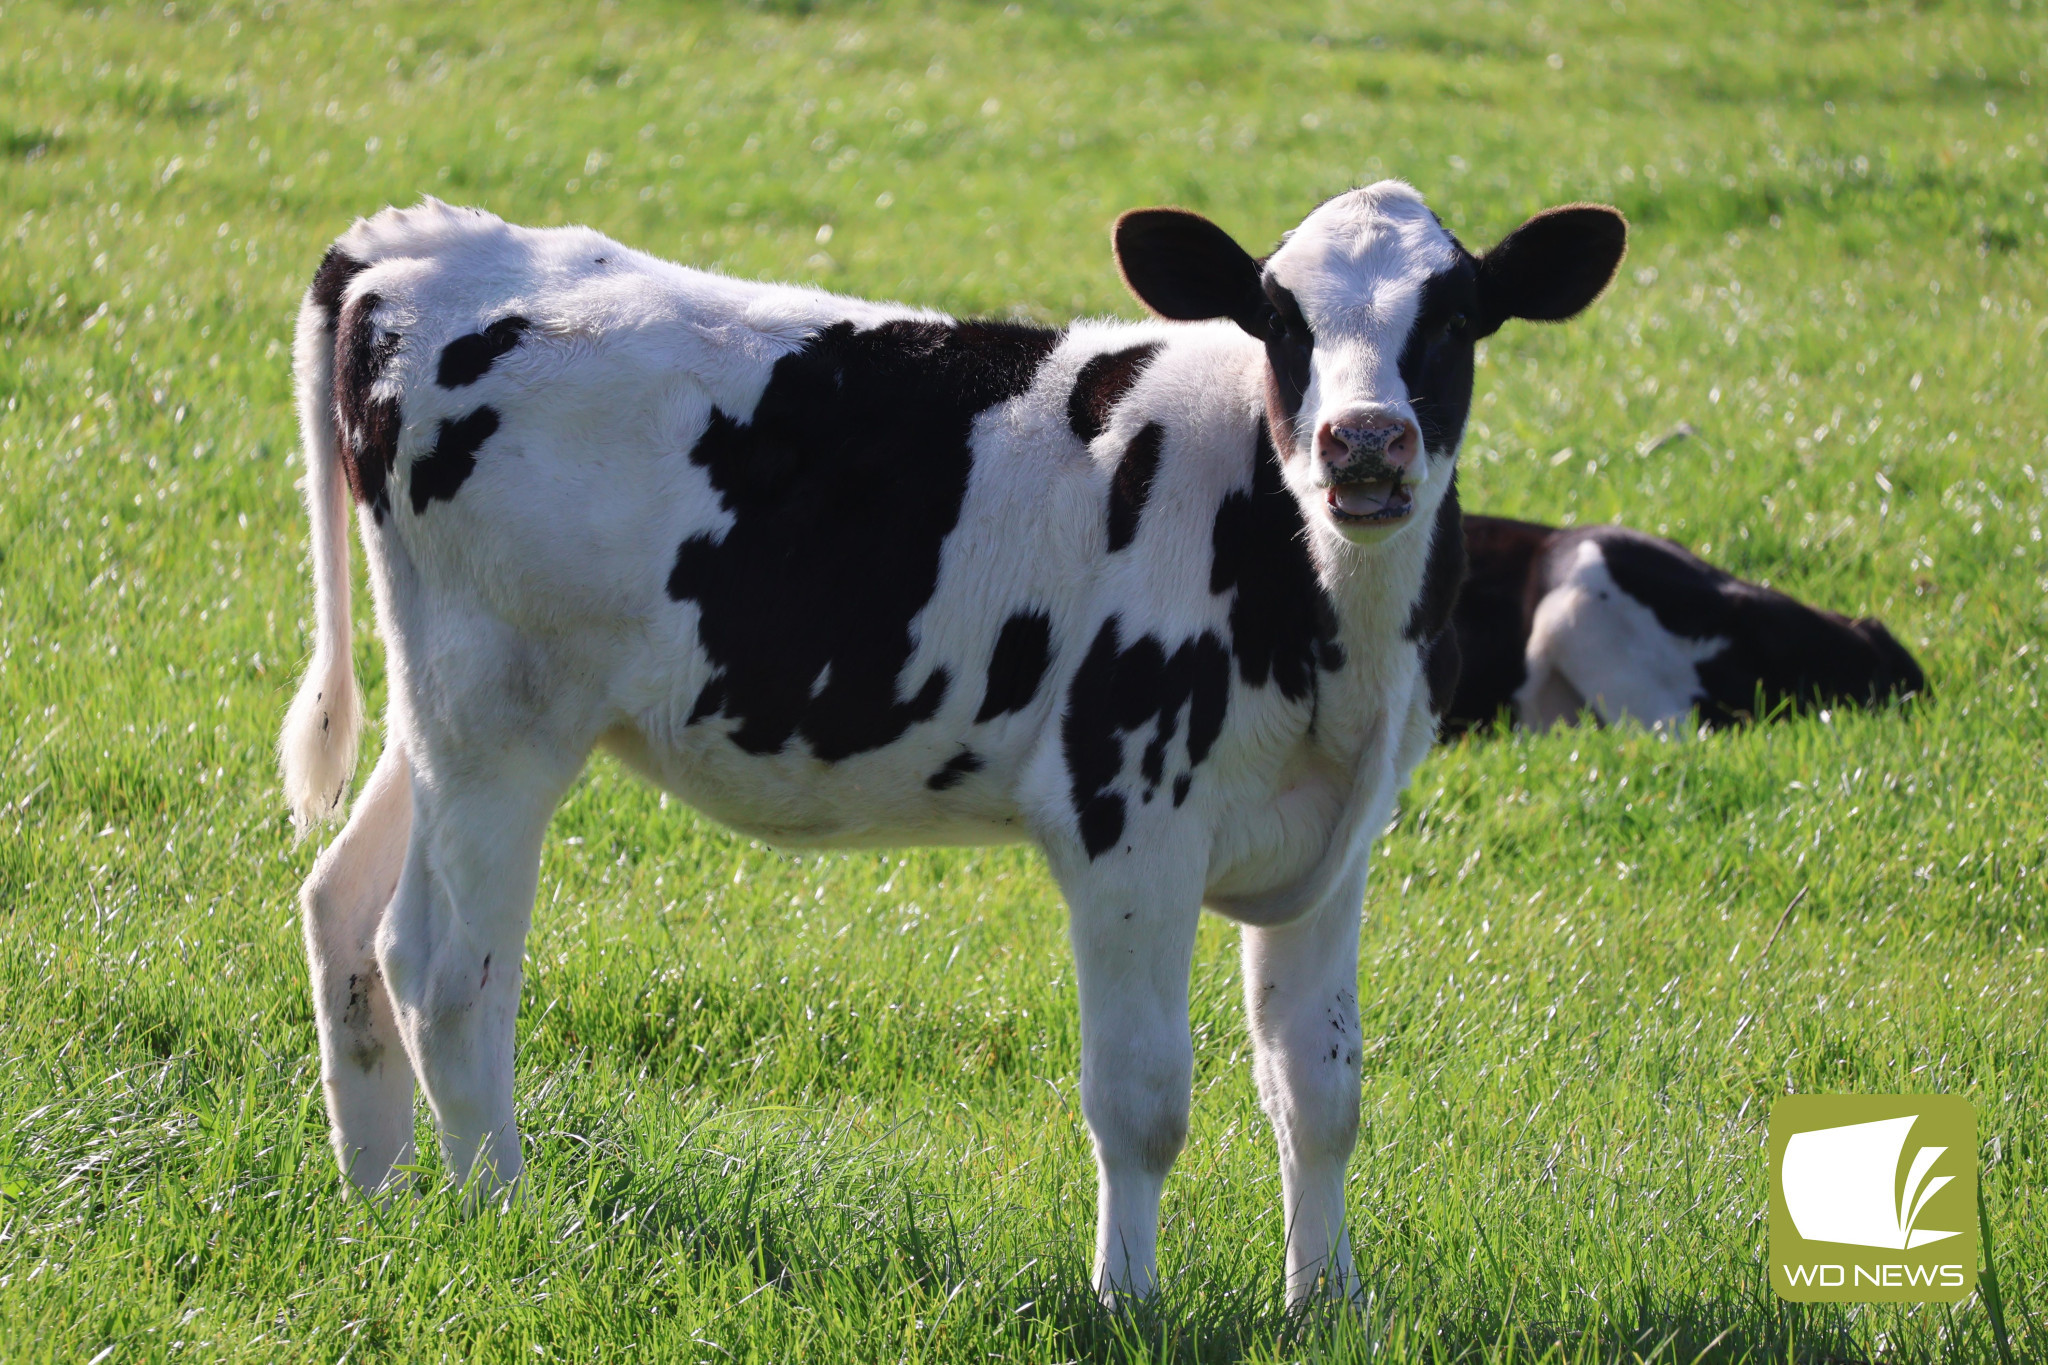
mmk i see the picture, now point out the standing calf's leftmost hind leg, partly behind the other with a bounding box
[299,741,412,1191]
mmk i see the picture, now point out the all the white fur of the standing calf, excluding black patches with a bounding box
[283,184,1456,1302]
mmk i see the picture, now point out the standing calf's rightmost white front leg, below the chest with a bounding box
[1243,860,1364,1306]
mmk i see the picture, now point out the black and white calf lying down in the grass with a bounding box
[1446,516,1927,735]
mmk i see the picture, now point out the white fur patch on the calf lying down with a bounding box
[1516,540,1729,735]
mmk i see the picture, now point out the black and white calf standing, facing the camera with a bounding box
[283,182,1626,1300]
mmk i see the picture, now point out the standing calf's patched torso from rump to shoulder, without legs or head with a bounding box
[323,205,1294,843]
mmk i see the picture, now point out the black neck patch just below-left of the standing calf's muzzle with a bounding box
[1208,422,1343,702]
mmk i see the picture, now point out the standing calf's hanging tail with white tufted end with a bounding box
[276,254,362,833]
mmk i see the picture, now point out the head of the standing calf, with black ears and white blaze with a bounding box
[1116,180,1628,542]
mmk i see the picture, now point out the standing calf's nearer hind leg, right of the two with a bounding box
[377,751,580,1193]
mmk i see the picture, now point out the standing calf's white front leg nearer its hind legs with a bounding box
[1061,845,1202,1306]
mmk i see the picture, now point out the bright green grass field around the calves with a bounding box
[0,0,2048,1365]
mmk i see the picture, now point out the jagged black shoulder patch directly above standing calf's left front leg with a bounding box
[1059,616,1231,857]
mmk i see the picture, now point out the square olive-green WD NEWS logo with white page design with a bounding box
[1772,1095,1976,1304]
